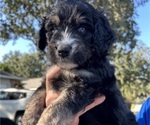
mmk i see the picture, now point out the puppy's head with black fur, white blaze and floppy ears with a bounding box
[38,0,114,69]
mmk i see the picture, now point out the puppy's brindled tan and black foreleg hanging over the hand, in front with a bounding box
[37,85,94,125]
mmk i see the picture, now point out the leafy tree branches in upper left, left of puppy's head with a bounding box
[0,0,60,44]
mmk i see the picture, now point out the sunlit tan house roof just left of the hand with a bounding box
[22,78,42,89]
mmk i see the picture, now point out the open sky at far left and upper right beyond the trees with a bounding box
[0,1,150,61]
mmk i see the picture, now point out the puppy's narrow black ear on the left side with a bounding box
[37,17,47,51]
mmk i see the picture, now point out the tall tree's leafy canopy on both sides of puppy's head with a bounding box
[0,0,147,48]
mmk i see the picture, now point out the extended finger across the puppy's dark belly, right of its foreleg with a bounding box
[78,95,106,116]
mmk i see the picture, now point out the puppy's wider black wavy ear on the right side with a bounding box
[94,11,116,56]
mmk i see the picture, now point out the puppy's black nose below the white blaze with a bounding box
[57,45,71,58]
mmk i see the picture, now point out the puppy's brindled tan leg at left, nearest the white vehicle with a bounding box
[22,87,45,125]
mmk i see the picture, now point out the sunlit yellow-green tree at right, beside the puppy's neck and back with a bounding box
[114,44,150,101]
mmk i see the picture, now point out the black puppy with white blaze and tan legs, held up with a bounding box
[22,0,136,125]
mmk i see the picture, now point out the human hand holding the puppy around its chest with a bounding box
[45,65,106,125]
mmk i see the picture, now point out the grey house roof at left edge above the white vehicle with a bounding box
[0,71,24,81]
